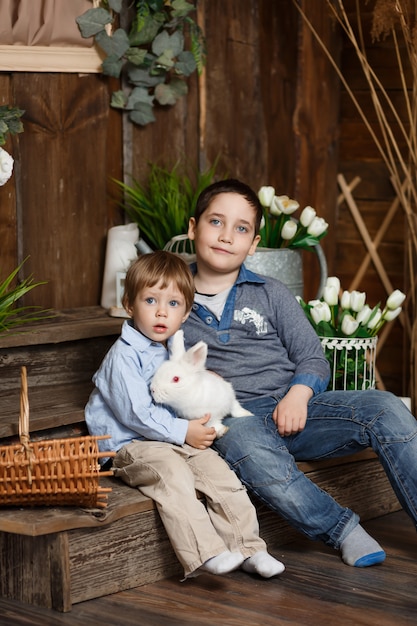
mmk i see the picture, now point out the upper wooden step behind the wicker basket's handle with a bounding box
[0,307,123,439]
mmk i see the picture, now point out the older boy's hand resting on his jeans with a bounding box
[272,385,313,437]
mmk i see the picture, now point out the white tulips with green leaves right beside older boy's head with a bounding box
[258,186,329,250]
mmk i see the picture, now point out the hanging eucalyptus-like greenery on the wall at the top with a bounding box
[76,0,205,126]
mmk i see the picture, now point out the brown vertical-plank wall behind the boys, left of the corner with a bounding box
[0,0,335,308]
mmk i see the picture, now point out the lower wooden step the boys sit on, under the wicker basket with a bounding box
[0,451,400,611]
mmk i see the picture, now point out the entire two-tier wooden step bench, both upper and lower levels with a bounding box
[0,307,400,611]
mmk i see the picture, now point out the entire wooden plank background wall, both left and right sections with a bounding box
[0,0,405,393]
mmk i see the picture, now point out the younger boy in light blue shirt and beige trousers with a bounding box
[85,251,284,578]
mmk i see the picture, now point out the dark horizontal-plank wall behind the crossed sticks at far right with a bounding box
[334,0,410,395]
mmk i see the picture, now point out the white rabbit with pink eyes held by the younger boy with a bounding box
[151,330,252,437]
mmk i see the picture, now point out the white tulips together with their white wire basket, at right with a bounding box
[297,276,406,390]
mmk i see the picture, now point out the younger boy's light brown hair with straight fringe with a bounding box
[122,250,194,312]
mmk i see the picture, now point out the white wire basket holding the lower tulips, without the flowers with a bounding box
[320,337,378,391]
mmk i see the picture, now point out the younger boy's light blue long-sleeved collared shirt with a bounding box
[85,320,188,462]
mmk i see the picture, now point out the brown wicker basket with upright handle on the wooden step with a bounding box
[0,367,114,507]
